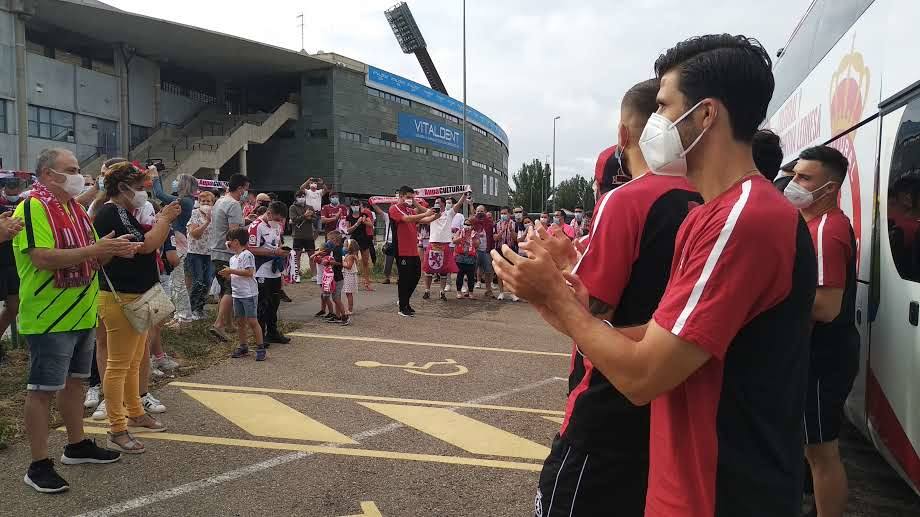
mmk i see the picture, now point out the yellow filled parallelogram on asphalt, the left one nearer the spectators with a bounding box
[182,390,358,444]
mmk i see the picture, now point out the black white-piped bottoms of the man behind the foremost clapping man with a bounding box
[534,435,648,517]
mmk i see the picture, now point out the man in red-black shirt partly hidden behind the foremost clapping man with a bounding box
[535,79,703,517]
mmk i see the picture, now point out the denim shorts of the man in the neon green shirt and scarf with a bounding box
[23,329,96,391]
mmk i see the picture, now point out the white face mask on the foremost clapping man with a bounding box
[639,101,709,176]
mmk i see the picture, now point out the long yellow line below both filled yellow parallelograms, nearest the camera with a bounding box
[73,426,543,472]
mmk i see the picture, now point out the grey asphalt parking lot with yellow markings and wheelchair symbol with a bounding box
[0,285,920,517]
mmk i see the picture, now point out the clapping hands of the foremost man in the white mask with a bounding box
[492,241,578,305]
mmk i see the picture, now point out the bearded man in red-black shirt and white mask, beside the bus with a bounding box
[784,146,859,517]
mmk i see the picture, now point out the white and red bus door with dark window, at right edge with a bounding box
[866,94,920,487]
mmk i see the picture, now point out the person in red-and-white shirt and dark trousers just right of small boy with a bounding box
[249,201,291,344]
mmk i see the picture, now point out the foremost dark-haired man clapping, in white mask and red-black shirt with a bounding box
[494,35,817,517]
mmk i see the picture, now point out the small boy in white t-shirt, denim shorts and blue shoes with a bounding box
[217,228,265,361]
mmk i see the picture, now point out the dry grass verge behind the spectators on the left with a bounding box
[0,305,299,450]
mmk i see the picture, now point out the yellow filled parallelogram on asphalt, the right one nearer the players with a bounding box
[359,402,549,460]
